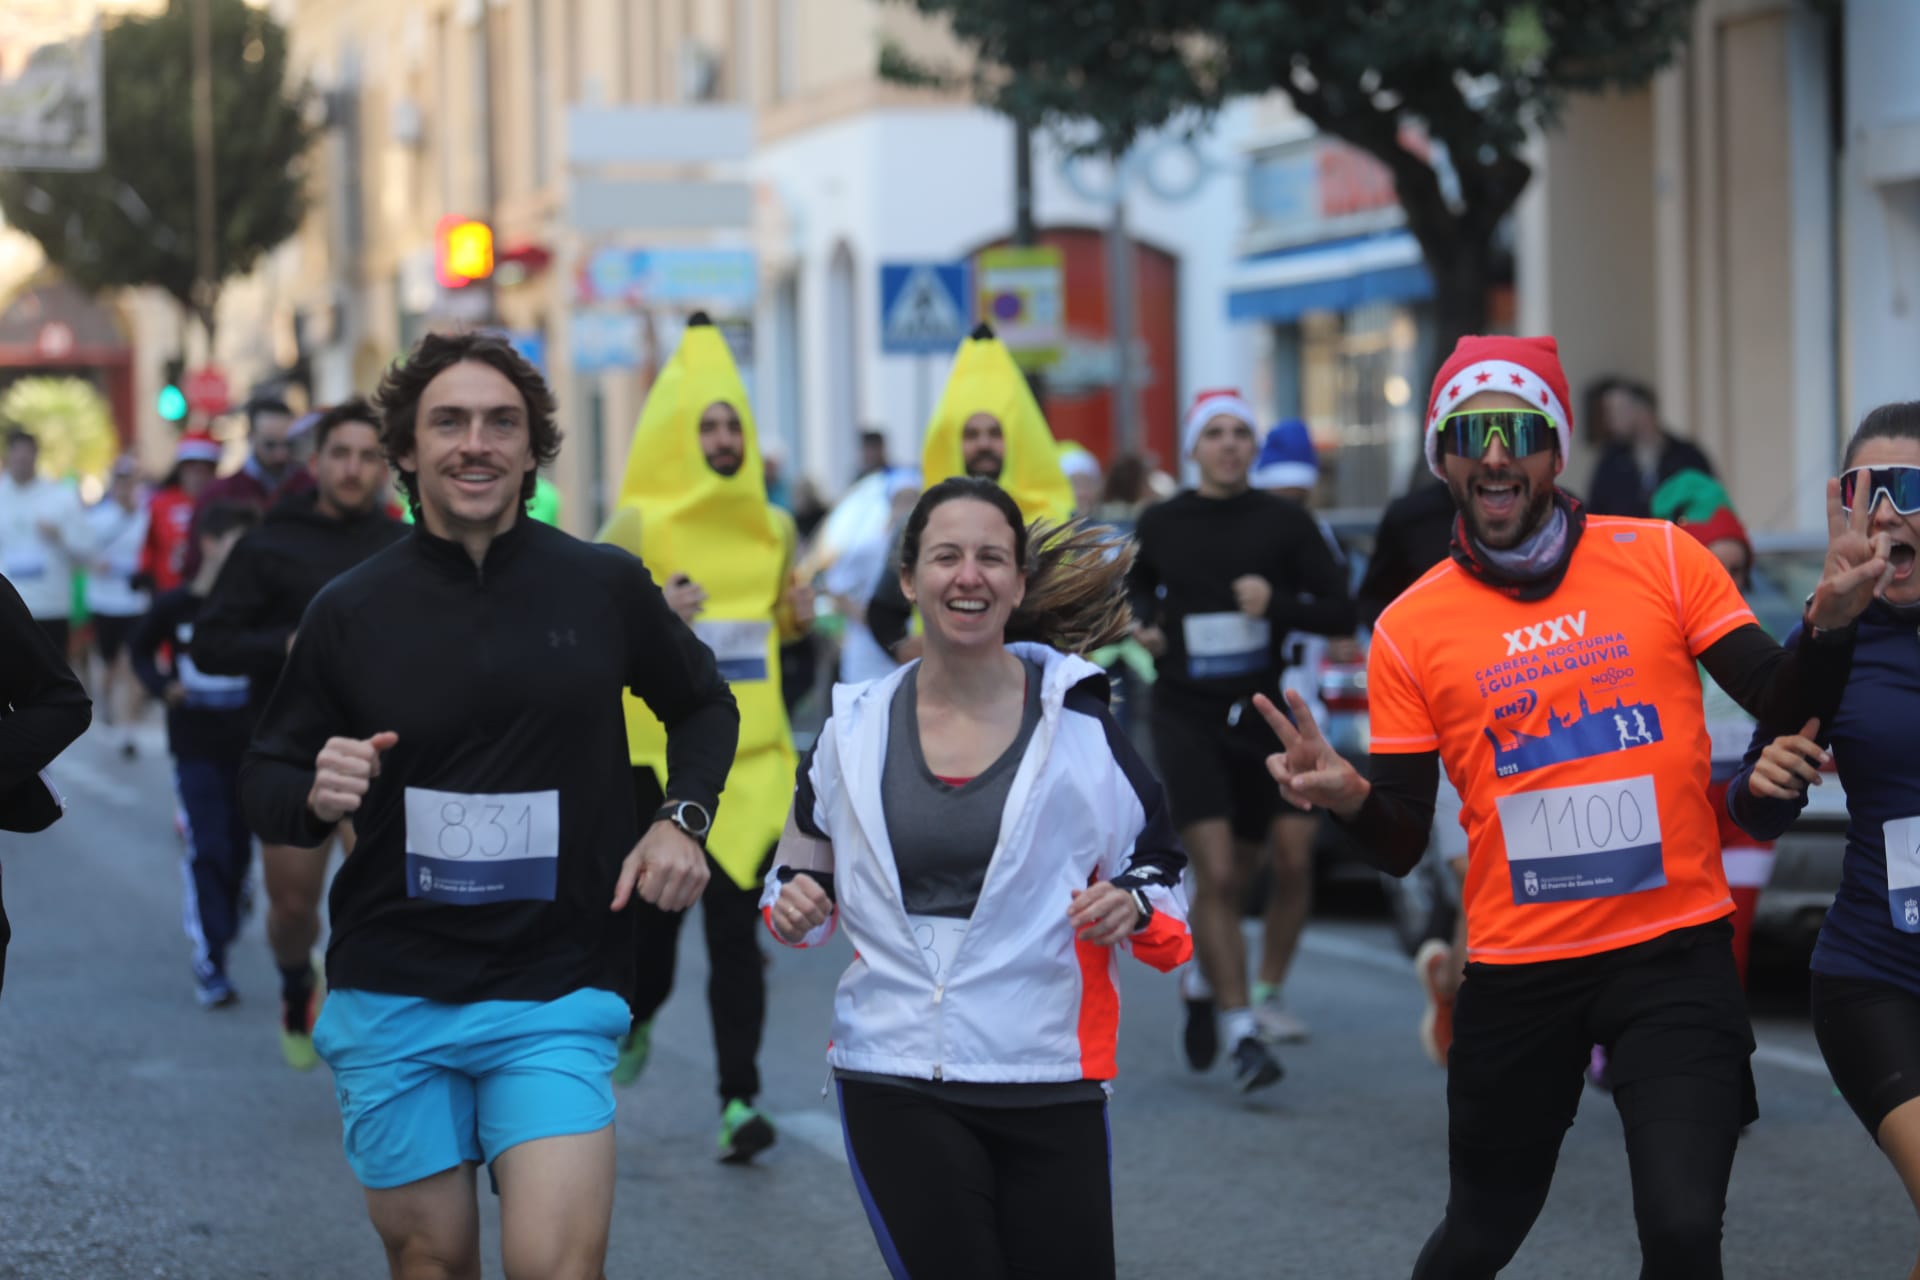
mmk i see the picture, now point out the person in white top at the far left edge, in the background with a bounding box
[0,426,90,656]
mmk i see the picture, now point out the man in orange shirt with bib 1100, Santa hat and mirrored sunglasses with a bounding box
[1256,338,1887,1280]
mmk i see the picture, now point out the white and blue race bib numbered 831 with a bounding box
[407,787,561,906]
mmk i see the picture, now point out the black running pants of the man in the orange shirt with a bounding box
[1413,921,1757,1280]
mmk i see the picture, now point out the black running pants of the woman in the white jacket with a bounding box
[839,1080,1114,1280]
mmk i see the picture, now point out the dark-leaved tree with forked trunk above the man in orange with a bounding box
[881,0,1693,364]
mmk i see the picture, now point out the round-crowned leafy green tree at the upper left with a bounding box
[0,0,313,342]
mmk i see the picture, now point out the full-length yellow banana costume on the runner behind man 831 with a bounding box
[599,317,799,889]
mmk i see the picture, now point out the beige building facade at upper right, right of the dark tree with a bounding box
[1517,0,1920,530]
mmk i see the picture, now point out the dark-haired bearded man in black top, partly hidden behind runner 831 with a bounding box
[192,397,407,1071]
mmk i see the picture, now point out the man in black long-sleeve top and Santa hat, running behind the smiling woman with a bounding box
[1127,393,1354,1090]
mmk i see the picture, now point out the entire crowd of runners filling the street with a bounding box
[0,315,1920,1280]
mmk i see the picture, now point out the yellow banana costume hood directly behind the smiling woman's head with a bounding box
[920,324,1073,522]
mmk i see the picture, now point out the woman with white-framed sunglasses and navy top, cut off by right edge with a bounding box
[1728,401,1920,1280]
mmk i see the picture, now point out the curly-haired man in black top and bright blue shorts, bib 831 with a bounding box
[242,334,739,1276]
